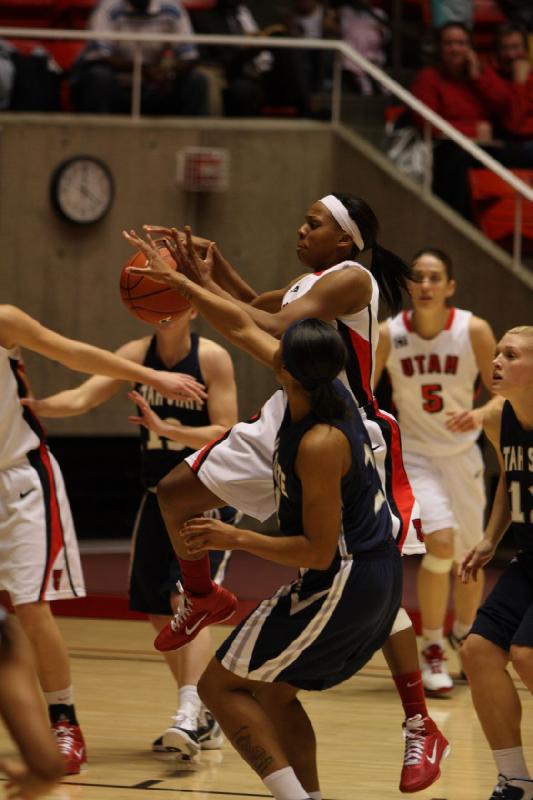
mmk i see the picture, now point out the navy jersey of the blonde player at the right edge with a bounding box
[500,400,533,552]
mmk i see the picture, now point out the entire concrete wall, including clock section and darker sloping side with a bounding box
[0,114,531,434]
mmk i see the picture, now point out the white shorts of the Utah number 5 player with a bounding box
[404,444,486,562]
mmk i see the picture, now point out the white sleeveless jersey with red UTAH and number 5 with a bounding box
[385,308,479,456]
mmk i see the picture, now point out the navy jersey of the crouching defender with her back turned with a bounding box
[274,380,393,573]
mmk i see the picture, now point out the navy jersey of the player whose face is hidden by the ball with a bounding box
[135,333,211,487]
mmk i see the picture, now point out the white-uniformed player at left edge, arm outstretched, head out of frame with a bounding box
[0,305,205,775]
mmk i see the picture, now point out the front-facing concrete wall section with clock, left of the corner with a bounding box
[0,115,333,434]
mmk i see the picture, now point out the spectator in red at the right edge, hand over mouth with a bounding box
[495,22,533,148]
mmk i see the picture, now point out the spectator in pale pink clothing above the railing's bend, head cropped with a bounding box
[333,0,390,95]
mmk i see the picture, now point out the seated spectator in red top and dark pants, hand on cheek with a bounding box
[412,22,510,219]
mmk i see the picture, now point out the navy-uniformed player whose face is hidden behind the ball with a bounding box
[22,309,237,757]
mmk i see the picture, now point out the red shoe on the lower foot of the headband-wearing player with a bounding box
[400,714,450,792]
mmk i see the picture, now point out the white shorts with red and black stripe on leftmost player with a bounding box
[0,445,85,606]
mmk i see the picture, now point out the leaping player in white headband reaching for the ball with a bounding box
[126,195,448,792]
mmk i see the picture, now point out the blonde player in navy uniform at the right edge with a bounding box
[460,326,533,800]
